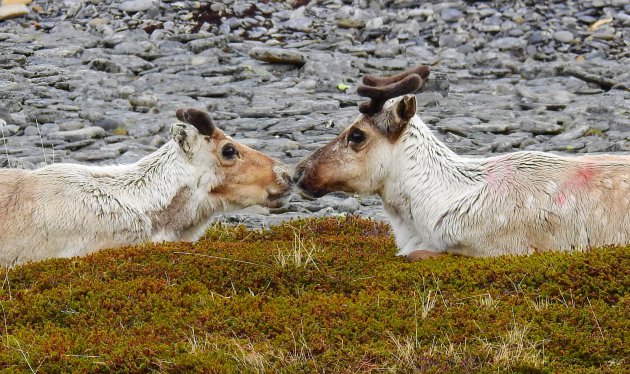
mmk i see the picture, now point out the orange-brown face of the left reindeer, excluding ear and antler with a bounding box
[209,129,291,208]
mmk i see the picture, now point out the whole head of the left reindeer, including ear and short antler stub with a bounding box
[171,108,292,209]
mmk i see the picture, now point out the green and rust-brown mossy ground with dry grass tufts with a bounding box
[0,218,630,373]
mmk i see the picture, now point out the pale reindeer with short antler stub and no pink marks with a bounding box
[0,109,292,266]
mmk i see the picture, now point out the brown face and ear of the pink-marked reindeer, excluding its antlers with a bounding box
[293,96,416,197]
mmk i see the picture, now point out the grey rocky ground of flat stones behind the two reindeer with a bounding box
[0,0,630,227]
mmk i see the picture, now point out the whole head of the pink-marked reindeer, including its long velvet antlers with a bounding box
[293,65,429,197]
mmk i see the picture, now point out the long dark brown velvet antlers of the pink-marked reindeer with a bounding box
[357,65,431,115]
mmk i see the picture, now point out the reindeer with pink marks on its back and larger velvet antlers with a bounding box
[293,66,630,260]
